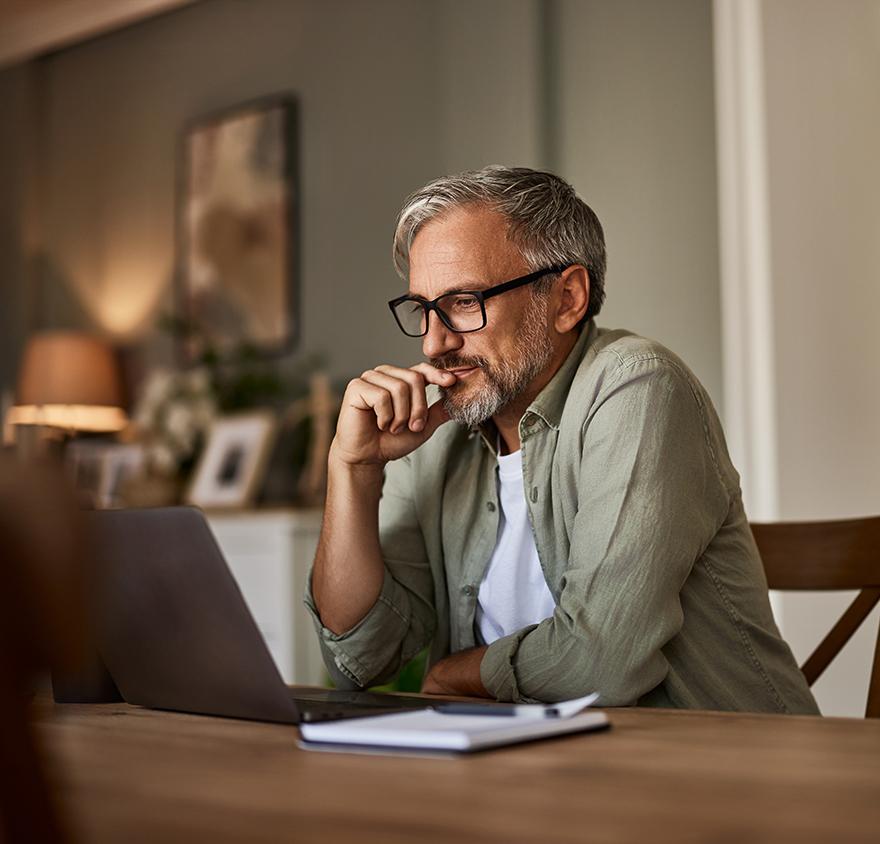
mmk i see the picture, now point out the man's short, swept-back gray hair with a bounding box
[394,165,607,321]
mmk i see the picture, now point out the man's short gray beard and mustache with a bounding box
[431,296,553,428]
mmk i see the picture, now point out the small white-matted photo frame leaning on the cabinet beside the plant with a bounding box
[186,411,276,510]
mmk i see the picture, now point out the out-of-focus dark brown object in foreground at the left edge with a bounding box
[0,454,86,844]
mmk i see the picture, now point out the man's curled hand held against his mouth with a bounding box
[331,363,456,466]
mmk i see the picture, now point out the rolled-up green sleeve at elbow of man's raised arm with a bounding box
[305,457,436,688]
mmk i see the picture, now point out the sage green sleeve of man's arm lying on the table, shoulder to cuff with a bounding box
[480,356,730,706]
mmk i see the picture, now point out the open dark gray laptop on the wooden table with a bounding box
[87,507,474,724]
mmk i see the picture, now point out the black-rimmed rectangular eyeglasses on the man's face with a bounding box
[388,264,571,337]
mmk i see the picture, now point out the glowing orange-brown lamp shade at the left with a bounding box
[11,331,126,431]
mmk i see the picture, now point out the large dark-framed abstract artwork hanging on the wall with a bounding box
[176,96,299,362]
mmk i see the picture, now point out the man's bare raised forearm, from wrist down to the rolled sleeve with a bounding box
[312,450,385,633]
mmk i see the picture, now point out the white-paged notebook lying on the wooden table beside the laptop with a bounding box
[299,695,609,754]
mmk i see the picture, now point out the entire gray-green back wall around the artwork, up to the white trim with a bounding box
[0,0,721,408]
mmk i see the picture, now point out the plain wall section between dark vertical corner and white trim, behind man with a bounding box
[557,0,722,410]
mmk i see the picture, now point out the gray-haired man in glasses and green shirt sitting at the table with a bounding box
[306,167,817,713]
